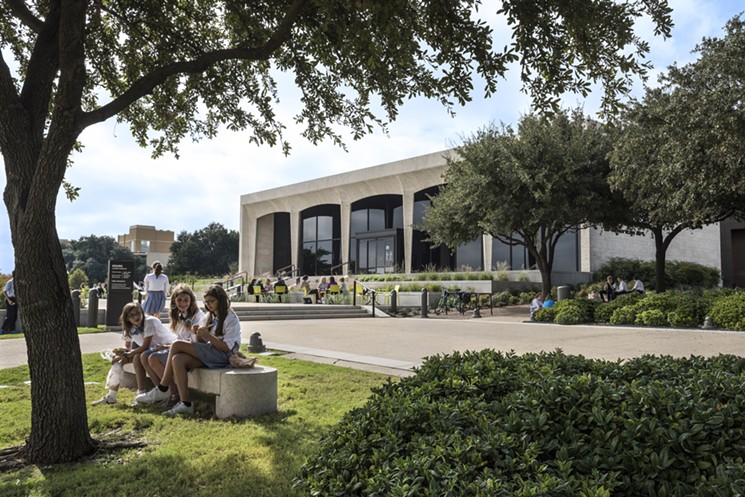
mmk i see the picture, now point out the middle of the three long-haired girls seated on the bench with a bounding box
[141,283,205,400]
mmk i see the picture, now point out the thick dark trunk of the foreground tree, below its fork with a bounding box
[4,154,94,464]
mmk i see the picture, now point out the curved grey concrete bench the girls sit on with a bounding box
[121,363,277,419]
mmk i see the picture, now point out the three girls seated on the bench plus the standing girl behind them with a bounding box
[93,262,241,416]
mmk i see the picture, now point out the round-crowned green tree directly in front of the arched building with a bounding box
[424,110,623,294]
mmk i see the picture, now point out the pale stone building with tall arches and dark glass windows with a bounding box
[239,150,745,286]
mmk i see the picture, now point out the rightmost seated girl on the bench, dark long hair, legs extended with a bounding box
[135,285,241,416]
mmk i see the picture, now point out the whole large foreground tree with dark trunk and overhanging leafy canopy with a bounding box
[0,0,671,463]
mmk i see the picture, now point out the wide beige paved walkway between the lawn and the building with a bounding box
[0,308,745,376]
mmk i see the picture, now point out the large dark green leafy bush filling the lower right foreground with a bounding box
[296,350,745,497]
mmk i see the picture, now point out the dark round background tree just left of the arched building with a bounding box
[167,223,240,276]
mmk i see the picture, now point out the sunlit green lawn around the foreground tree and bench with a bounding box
[0,354,387,497]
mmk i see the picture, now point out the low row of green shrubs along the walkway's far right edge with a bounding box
[535,289,745,330]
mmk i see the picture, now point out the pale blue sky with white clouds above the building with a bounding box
[0,0,745,273]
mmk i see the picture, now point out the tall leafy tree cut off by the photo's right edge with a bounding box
[609,18,745,292]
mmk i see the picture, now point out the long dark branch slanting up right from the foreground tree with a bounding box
[79,0,308,131]
